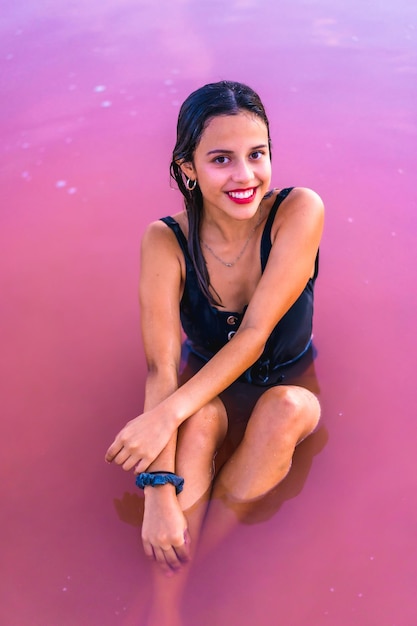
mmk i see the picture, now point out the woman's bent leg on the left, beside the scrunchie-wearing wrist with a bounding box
[146,399,227,626]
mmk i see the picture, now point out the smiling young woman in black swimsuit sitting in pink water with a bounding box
[106,81,323,625]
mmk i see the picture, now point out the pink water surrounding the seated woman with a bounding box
[0,0,417,626]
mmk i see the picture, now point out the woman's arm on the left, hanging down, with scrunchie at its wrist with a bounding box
[139,221,189,574]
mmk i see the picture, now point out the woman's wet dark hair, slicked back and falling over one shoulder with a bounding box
[170,80,271,305]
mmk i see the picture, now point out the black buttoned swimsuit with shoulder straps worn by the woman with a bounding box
[162,188,318,385]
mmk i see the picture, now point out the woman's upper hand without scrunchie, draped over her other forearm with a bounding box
[105,411,176,474]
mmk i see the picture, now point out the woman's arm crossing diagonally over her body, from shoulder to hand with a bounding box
[105,188,324,472]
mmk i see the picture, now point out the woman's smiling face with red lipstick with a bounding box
[182,112,271,220]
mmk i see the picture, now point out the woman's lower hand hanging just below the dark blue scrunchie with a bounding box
[142,485,190,576]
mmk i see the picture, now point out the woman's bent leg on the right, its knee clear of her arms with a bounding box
[198,385,320,555]
